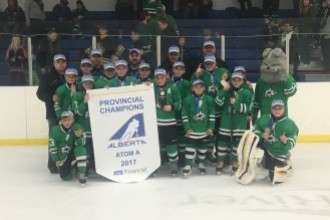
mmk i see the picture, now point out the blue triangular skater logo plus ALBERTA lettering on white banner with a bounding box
[108,113,146,148]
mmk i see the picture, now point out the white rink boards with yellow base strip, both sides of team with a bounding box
[0,83,330,145]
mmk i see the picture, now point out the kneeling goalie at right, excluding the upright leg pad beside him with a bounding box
[254,99,299,185]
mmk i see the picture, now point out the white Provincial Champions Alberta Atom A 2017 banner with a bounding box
[88,85,160,183]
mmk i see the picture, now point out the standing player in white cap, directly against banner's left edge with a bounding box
[72,74,95,173]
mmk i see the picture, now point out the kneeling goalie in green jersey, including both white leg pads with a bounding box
[236,100,299,185]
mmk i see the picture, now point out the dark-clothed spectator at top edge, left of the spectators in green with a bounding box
[116,0,134,36]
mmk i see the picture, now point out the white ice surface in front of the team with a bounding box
[0,144,330,220]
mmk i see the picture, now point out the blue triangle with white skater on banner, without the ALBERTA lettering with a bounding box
[110,113,145,142]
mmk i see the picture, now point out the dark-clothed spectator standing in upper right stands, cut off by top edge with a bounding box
[299,0,316,67]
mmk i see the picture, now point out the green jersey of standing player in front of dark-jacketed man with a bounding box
[54,83,72,118]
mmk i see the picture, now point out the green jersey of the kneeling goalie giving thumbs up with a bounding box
[254,114,299,160]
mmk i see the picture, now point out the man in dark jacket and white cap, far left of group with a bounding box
[36,54,67,173]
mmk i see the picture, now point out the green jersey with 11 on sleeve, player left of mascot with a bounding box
[215,87,252,137]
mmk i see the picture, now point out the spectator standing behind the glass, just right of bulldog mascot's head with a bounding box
[277,19,300,79]
